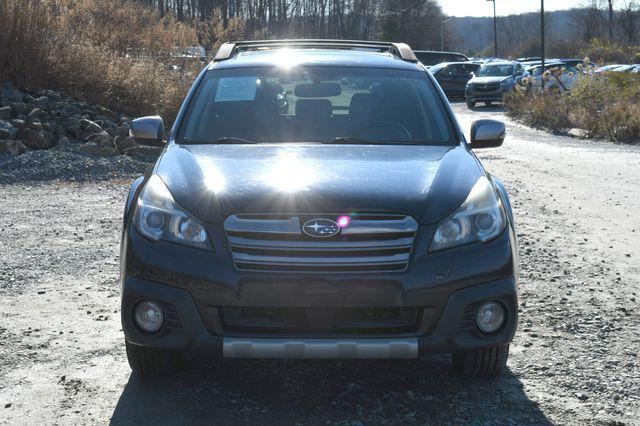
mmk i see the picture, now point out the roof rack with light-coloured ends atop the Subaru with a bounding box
[213,39,418,62]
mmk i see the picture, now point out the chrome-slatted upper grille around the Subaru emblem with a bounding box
[224,214,418,272]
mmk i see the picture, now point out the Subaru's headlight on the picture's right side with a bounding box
[429,176,506,251]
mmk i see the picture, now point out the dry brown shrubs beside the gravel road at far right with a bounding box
[505,73,640,143]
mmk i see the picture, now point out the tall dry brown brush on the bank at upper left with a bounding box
[0,0,201,121]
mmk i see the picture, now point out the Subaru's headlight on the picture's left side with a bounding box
[133,175,211,250]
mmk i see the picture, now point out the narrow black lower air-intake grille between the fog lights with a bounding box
[218,307,422,335]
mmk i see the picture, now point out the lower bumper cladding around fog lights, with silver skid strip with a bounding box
[122,278,518,358]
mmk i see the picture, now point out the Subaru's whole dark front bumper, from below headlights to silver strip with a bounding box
[121,221,517,358]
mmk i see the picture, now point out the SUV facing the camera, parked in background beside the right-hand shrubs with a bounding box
[465,61,529,108]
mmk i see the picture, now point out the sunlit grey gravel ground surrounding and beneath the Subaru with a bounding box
[0,104,640,425]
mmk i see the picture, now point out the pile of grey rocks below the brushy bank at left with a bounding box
[0,83,160,160]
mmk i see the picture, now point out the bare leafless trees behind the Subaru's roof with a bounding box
[132,0,444,49]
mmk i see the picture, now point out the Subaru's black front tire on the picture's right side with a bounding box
[451,344,509,376]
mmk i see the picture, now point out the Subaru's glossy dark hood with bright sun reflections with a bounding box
[154,144,484,224]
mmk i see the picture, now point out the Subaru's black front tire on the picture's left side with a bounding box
[125,342,184,377]
